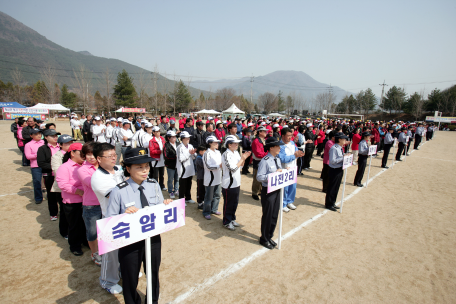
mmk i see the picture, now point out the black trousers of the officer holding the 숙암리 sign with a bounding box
[119,235,161,304]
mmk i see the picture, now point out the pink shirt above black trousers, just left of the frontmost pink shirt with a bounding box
[55,159,84,204]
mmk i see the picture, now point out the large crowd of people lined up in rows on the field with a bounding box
[11,113,435,303]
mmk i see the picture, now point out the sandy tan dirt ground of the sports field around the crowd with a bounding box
[0,121,456,304]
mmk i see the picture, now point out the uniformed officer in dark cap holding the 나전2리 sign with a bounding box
[256,137,284,249]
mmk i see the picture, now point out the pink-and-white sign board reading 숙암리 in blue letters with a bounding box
[97,198,185,255]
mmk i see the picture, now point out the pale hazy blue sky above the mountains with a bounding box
[0,0,456,97]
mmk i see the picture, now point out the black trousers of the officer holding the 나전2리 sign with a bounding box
[260,187,281,242]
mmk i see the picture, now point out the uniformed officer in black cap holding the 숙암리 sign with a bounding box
[106,148,171,304]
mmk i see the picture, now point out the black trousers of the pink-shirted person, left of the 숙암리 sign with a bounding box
[63,203,87,251]
